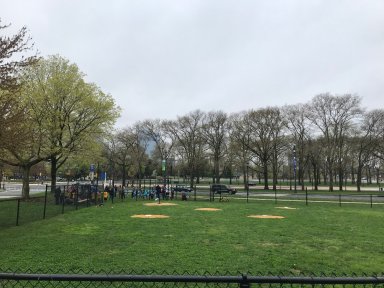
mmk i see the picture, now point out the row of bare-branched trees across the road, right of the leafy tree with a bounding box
[106,93,384,191]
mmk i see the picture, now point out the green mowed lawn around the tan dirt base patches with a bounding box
[0,199,384,275]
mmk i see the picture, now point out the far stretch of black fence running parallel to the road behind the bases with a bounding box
[126,179,384,207]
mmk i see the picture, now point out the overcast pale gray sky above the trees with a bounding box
[0,0,384,127]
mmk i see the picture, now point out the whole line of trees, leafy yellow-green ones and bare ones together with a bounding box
[0,22,384,197]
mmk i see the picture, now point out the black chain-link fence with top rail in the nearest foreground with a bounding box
[0,270,384,288]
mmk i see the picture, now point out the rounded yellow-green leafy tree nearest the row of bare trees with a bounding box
[26,56,120,192]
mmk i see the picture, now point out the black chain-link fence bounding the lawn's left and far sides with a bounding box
[0,184,384,227]
